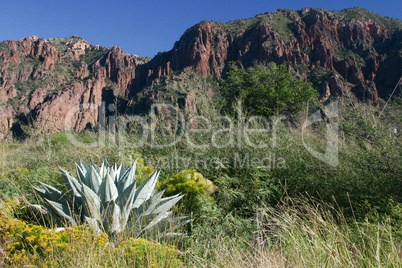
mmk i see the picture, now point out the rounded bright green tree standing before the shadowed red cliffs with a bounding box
[221,62,318,116]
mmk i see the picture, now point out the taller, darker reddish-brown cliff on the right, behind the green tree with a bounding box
[142,9,402,104]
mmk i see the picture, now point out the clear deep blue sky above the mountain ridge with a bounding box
[0,0,402,57]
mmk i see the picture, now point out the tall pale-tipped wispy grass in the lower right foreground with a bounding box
[185,197,402,267]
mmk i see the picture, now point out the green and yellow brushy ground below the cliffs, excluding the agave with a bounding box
[0,94,402,267]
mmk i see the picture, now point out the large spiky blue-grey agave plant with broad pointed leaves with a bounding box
[34,158,189,237]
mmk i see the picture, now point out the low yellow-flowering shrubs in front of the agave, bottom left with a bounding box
[0,200,182,267]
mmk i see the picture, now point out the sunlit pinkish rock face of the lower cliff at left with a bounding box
[0,36,149,139]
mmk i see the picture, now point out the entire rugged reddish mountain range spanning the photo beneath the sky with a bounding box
[0,8,402,139]
